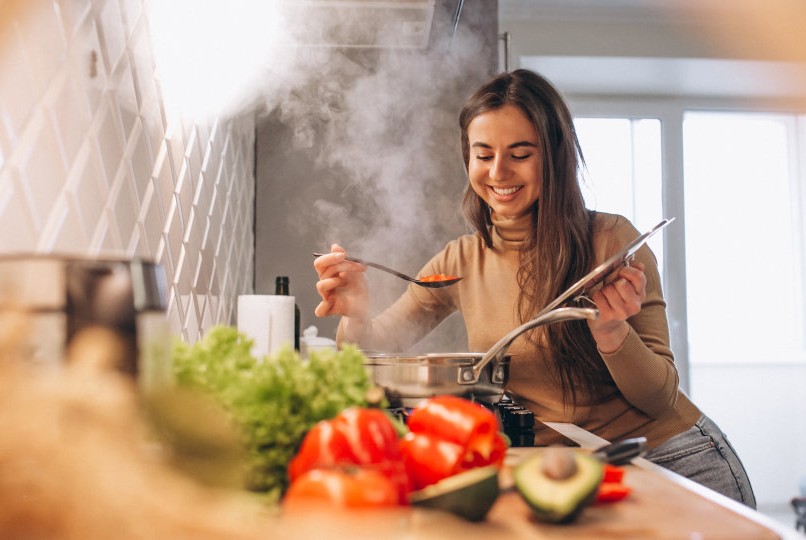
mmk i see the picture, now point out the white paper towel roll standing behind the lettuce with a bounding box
[238,294,295,359]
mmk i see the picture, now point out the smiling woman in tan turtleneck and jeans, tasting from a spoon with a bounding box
[314,70,755,508]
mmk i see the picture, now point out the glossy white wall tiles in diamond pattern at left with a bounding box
[0,0,255,341]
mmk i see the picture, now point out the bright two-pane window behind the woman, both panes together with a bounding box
[575,107,806,363]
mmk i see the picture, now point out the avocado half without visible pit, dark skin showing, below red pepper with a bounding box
[411,465,499,521]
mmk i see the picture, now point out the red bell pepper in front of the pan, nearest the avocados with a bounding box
[400,396,507,489]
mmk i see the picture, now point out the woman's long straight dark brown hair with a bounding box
[459,69,612,403]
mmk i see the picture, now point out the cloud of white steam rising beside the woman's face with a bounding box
[267,38,486,324]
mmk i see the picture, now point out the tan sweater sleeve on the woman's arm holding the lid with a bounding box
[600,219,679,418]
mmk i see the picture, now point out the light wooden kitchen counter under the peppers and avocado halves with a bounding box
[278,423,802,540]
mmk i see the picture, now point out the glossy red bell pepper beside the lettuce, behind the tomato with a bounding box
[288,407,411,504]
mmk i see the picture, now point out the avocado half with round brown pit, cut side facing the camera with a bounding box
[514,448,604,523]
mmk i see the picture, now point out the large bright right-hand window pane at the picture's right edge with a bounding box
[683,112,804,362]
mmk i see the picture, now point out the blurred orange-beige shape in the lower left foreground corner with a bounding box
[0,326,274,540]
